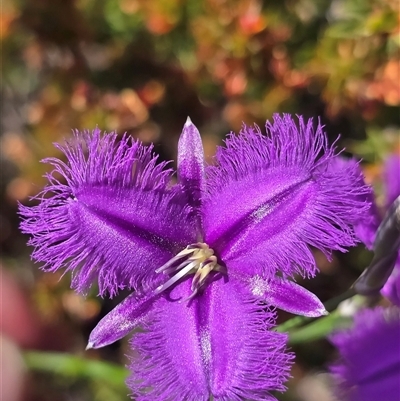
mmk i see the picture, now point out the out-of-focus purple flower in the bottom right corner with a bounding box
[332,306,400,401]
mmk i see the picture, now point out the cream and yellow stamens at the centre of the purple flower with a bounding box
[155,242,224,301]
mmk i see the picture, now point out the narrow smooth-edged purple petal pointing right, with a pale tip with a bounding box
[250,276,328,317]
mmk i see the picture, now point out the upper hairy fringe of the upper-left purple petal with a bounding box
[50,128,172,191]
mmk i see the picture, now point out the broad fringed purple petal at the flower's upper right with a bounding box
[204,115,370,277]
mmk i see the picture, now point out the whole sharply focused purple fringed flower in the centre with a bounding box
[21,115,369,401]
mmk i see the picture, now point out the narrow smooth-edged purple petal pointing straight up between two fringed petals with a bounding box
[178,117,205,228]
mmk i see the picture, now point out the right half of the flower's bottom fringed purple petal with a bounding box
[205,280,293,401]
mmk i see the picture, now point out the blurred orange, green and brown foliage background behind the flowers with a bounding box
[0,0,400,401]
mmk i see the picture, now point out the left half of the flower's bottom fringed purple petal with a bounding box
[127,280,209,401]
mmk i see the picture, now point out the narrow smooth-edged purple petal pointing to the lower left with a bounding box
[86,293,155,349]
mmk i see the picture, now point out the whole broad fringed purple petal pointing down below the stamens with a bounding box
[128,280,293,401]
